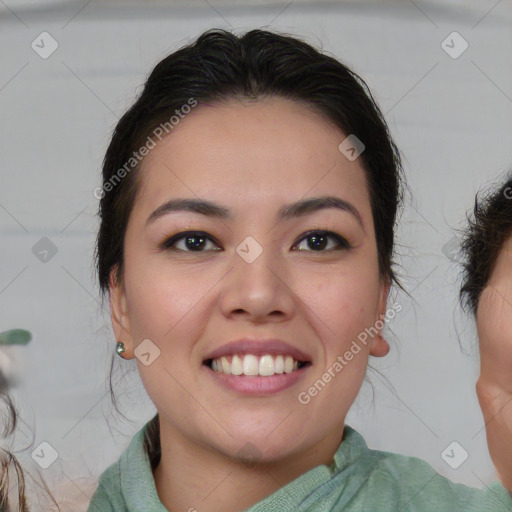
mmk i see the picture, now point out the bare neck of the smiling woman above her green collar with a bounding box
[153,417,343,512]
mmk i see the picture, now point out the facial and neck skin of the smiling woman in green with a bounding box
[110,98,389,512]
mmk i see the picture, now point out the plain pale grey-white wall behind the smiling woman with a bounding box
[0,0,512,506]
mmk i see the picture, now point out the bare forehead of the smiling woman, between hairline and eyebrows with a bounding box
[132,98,370,221]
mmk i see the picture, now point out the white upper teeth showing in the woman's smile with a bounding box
[211,354,299,377]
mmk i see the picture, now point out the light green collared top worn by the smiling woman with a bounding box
[87,422,512,512]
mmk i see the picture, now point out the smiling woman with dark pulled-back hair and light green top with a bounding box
[85,30,512,512]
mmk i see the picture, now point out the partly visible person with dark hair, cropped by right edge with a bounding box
[461,174,512,489]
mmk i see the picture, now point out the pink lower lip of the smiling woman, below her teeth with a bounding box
[203,365,311,395]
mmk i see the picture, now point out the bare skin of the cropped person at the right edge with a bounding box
[476,236,512,491]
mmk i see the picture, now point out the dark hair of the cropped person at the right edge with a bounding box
[460,172,512,315]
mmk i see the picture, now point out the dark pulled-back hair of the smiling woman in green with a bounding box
[95,29,402,294]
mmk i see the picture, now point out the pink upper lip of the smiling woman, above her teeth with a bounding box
[205,338,311,362]
